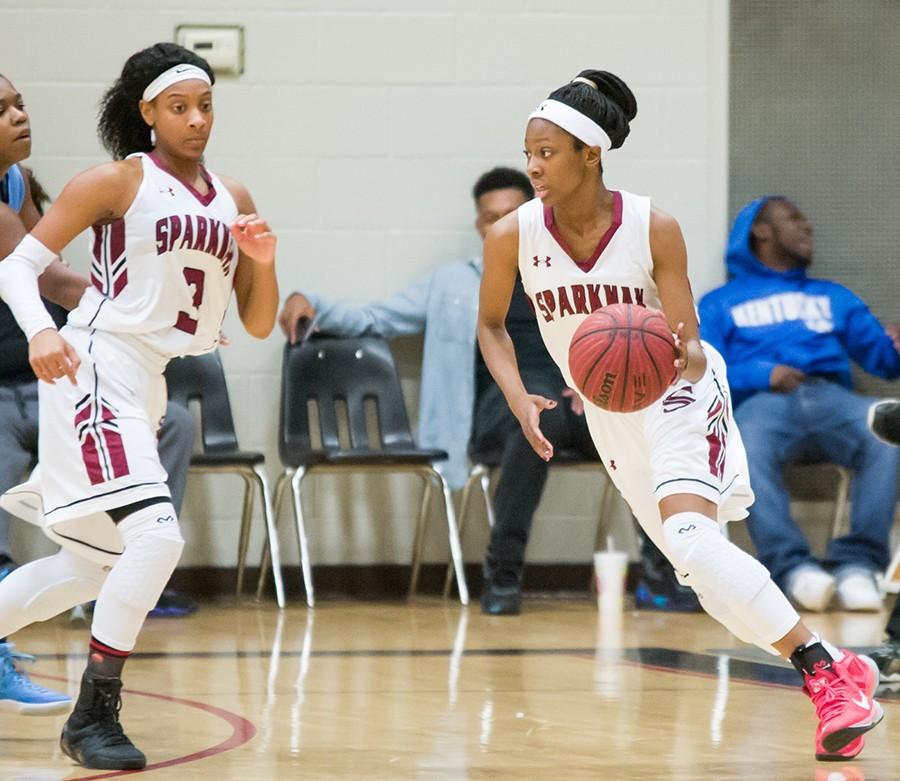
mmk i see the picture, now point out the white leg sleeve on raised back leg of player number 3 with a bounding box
[0,549,108,637]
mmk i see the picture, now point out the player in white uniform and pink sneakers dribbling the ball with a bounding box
[478,71,882,760]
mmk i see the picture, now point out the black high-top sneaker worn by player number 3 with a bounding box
[59,673,147,770]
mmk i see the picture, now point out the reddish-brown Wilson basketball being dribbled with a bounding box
[569,304,678,412]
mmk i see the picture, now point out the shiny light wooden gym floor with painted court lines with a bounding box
[0,599,900,781]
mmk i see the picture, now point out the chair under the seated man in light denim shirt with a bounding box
[444,449,618,597]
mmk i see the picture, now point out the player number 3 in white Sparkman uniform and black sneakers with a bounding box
[0,43,278,770]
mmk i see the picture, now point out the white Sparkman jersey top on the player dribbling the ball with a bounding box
[518,191,661,388]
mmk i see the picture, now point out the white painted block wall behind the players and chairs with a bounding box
[0,0,728,565]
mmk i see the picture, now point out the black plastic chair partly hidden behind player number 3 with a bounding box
[166,352,284,607]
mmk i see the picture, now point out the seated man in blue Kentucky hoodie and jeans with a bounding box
[700,196,900,611]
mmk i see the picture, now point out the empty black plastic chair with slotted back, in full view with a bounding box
[257,337,469,606]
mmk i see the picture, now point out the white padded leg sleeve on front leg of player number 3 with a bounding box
[91,502,184,651]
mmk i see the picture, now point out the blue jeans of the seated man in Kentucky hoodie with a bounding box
[734,378,900,587]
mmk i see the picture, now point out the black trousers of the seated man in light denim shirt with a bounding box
[471,377,597,569]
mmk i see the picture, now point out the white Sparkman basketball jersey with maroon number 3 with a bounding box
[69,154,238,358]
